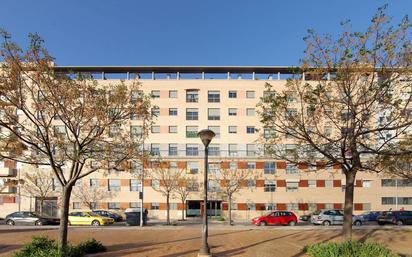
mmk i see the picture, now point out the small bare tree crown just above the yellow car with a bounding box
[73,185,116,210]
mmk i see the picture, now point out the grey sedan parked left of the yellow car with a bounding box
[5,211,60,226]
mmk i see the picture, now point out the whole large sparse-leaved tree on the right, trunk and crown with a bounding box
[261,7,412,240]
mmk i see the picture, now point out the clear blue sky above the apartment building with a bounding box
[0,0,412,66]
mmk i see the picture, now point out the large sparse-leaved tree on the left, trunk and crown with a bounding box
[0,32,151,247]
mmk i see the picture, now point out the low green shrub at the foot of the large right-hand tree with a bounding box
[303,241,399,257]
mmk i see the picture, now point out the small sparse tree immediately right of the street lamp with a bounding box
[211,162,256,225]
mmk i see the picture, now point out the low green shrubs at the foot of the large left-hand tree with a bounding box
[13,237,106,257]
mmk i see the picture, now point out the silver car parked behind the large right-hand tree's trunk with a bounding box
[311,209,364,226]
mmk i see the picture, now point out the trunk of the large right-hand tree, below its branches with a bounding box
[342,170,356,241]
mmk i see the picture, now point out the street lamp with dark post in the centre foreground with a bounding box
[197,129,215,257]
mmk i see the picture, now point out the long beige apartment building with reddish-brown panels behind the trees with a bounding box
[0,67,412,220]
